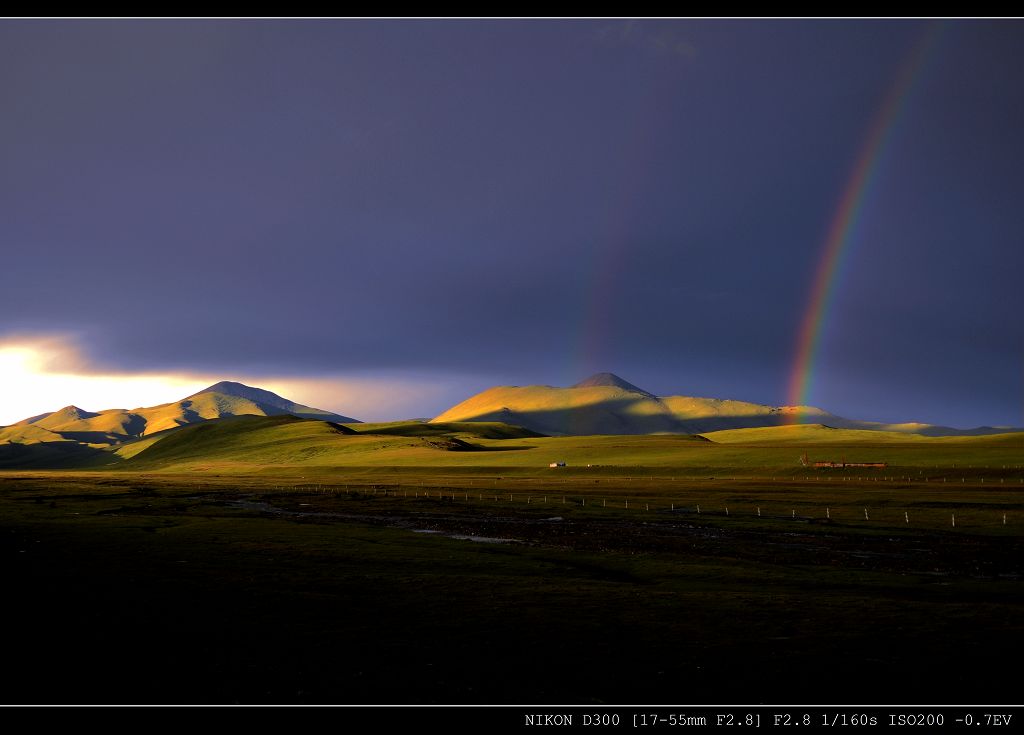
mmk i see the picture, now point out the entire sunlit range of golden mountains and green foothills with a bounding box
[0,373,1024,473]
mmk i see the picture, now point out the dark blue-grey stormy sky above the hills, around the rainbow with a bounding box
[0,20,1024,427]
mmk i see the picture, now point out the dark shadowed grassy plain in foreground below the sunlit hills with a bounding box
[0,472,1024,704]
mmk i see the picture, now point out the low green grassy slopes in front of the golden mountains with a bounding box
[103,416,1024,481]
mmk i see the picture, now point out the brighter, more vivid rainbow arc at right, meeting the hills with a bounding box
[786,24,943,423]
